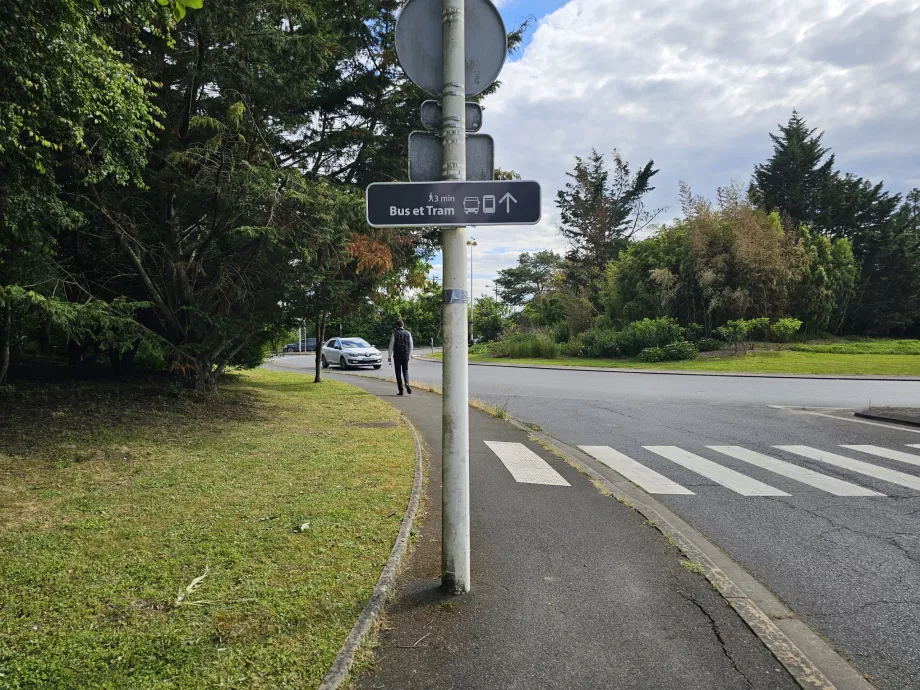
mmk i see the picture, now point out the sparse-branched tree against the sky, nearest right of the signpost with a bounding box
[556,150,660,301]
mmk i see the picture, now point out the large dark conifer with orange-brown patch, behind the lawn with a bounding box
[70,0,436,390]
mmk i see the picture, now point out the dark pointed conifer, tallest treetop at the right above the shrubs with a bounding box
[750,110,836,225]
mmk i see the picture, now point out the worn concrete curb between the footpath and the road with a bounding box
[509,420,874,690]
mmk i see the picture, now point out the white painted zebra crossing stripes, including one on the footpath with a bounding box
[485,441,920,497]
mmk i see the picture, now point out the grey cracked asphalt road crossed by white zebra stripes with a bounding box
[274,358,920,690]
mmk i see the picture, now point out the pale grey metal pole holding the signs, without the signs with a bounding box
[441,0,470,594]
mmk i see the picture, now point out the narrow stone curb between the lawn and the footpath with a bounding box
[319,412,423,690]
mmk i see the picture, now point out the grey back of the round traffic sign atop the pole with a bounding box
[396,0,508,96]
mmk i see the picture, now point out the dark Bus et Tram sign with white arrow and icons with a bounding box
[367,180,541,228]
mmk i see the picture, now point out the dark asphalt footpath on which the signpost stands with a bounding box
[347,376,799,690]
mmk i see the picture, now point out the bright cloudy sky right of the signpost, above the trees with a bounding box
[424,0,920,296]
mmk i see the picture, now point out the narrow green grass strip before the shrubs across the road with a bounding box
[430,350,920,376]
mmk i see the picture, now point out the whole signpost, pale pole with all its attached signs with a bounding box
[388,0,540,594]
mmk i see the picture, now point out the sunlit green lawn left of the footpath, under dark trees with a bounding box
[0,371,415,689]
